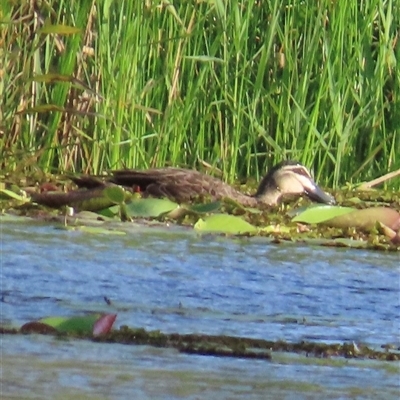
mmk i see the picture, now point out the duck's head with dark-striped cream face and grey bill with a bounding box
[255,161,336,204]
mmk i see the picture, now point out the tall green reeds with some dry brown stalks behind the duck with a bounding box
[0,0,400,190]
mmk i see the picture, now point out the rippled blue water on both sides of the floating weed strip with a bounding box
[0,217,400,399]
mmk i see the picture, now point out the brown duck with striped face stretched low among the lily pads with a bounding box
[31,160,336,208]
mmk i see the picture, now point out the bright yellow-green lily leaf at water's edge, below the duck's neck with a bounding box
[194,214,257,235]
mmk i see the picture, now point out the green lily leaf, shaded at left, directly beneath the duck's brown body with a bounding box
[126,198,179,218]
